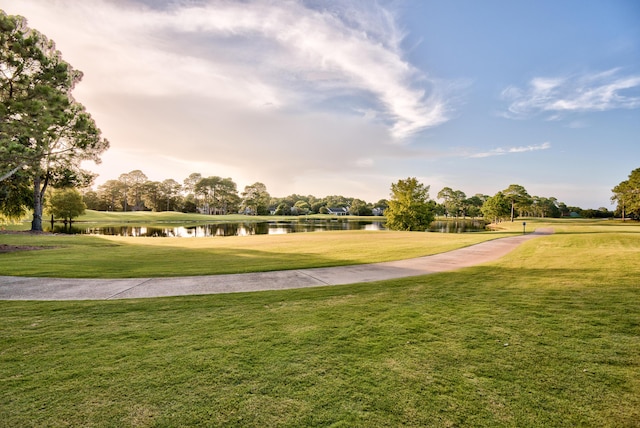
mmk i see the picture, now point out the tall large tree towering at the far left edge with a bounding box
[0,11,109,231]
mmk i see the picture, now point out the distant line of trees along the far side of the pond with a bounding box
[76,170,614,221]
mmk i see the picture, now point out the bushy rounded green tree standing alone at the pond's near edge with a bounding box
[385,177,435,231]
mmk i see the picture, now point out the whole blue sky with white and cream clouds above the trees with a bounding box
[0,0,640,209]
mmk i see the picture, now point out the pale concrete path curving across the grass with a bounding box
[0,228,553,300]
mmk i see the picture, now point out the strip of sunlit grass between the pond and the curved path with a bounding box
[0,231,509,278]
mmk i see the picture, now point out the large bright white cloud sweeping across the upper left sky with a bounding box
[43,0,450,141]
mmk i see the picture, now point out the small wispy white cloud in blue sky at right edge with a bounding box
[502,68,640,119]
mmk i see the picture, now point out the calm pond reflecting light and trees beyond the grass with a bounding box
[45,219,485,238]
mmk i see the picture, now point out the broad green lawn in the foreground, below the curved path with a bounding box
[0,222,640,427]
